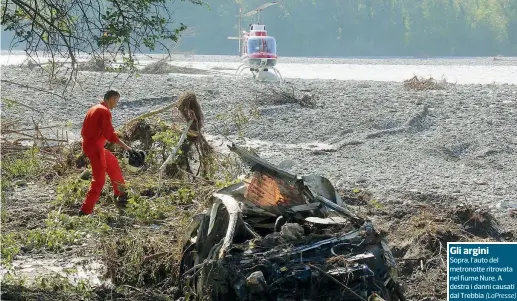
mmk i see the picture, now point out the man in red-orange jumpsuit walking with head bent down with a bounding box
[79,90,131,215]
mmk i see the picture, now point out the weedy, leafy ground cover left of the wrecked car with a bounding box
[1,108,247,300]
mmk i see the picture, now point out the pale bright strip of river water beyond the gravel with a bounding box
[0,50,517,84]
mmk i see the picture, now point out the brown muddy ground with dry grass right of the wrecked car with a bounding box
[343,191,517,300]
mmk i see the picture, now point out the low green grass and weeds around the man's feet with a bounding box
[1,107,246,300]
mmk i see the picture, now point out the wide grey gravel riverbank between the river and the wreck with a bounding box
[2,61,517,227]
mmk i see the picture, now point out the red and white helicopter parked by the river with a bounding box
[228,1,282,80]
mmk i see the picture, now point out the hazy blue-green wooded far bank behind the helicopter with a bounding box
[175,0,517,57]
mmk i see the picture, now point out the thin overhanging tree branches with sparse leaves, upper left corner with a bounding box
[1,0,203,83]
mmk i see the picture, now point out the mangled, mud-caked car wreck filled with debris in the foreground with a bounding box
[180,144,405,301]
